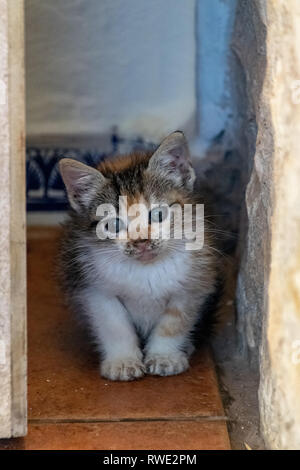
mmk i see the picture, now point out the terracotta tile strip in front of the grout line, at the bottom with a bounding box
[0,421,230,450]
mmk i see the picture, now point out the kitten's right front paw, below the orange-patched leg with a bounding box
[145,353,189,375]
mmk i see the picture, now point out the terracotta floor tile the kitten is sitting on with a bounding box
[28,228,224,420]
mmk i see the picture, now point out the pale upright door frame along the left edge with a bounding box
[0,0,27,438]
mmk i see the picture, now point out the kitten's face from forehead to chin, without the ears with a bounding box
[97,191,183,263]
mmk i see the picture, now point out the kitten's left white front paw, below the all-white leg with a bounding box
[100,357,145,381]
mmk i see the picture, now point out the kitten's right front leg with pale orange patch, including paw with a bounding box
[144,304,196,375]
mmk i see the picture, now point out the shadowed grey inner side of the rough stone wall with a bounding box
[233,0,272,367]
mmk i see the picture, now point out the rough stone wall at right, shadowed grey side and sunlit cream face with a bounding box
[234,0,300,449]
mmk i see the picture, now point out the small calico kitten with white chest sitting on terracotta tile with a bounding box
[60,131,218,380]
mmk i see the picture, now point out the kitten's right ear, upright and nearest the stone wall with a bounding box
[148,131,196,189]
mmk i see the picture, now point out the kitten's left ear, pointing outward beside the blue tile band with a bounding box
[59,158,105,212]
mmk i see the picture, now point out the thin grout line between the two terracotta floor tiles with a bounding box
[28,416,229,424]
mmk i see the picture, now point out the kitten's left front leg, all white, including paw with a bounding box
[84,289,145,381]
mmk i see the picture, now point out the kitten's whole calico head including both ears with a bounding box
[60,132,195,263]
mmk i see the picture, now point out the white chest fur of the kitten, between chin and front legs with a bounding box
[90,248,190,333]
